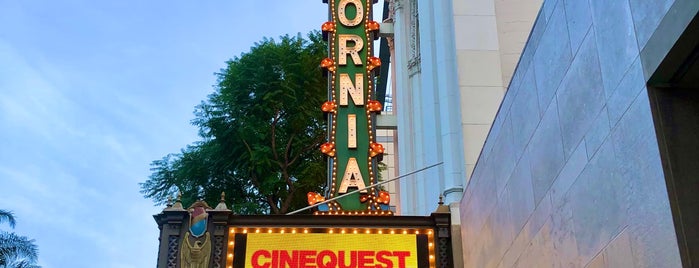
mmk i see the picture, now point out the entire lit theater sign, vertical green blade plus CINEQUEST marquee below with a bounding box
[154,0,460,268]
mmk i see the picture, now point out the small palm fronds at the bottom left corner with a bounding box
[0,209,40,268]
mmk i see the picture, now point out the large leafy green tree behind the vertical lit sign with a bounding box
[141,32,327,214]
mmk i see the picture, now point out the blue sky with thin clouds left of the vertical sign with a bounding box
[0,0,380,268]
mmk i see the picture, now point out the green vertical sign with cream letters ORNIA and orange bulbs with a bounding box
[308,0,390,214]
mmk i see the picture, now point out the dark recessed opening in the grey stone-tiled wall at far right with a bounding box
[648,8,699,267]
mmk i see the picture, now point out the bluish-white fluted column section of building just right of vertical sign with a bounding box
[392,0,464,215]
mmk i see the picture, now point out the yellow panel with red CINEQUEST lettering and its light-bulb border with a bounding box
[225,227,435,268]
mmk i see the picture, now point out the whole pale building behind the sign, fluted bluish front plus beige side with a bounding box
[391,0,541,215]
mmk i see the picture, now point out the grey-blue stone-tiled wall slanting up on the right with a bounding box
[460,0,699,267]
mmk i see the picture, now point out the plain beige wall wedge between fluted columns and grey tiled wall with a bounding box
[453,0,542,185]
